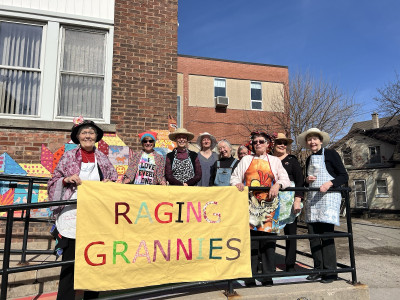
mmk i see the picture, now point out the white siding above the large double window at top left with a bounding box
[0,0,114,21]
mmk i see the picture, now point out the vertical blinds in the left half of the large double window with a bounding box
[0,22,42,115]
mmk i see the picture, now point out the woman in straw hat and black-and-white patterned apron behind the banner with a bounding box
[165,128,201,186]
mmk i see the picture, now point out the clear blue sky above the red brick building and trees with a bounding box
[178,0,400,121]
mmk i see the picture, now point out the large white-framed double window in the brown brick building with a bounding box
[0,15,113,123]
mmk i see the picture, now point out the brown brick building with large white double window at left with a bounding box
[0,0,178,163]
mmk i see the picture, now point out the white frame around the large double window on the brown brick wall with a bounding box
[0,12,114,124]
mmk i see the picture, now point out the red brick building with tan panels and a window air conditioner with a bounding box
[178,55,289,145]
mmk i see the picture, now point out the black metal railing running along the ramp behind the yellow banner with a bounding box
[0,175,357,300]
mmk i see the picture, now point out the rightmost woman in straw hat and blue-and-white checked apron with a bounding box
[297,128,349,283]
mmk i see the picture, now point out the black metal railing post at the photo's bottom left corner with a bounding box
[0,208,14,300]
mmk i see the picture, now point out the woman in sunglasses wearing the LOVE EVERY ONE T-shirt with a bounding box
[122,131,166,185]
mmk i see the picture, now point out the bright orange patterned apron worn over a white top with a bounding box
[244,156,279,233]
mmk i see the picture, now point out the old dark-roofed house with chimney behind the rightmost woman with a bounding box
[332,113,400,213]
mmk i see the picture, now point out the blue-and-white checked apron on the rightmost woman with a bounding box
[306,149,342,226]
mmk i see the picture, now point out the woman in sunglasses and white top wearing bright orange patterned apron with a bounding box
[231,131,290,286]
